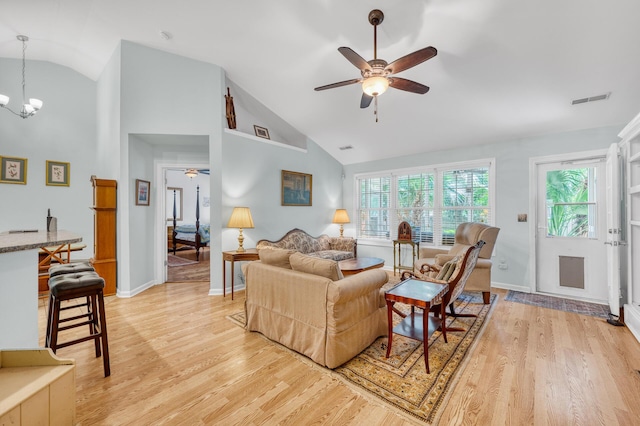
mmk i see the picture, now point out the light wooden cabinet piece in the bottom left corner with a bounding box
[0,349,76,425]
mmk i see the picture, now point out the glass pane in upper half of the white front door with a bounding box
[546,167,597,238]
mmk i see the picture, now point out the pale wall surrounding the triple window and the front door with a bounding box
[344,125,622,291]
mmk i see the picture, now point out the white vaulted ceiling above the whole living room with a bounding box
[0,0,640,164]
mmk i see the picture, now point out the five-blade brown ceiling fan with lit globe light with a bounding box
[314,9,438,122]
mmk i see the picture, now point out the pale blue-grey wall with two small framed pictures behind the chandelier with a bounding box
[0,58,97,258]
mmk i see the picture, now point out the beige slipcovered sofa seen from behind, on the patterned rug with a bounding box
[243,249,388,368]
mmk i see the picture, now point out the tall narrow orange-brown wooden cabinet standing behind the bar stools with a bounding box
[91,177,118,296]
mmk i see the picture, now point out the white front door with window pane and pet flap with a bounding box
[536,156,608,303]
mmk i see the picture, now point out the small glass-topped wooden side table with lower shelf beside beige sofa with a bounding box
[384,279,449,373]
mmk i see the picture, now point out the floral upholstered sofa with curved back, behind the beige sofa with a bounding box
[256,228,357,261]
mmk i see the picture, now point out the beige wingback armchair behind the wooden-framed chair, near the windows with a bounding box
[414,222,500,303]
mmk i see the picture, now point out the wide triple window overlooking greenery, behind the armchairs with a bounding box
[356,160,495,245]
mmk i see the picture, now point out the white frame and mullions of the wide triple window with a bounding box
[353,158,496,248]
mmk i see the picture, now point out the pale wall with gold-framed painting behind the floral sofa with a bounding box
[222,134,342,250]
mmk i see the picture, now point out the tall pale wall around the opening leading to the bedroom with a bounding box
[115,41,224,296]
